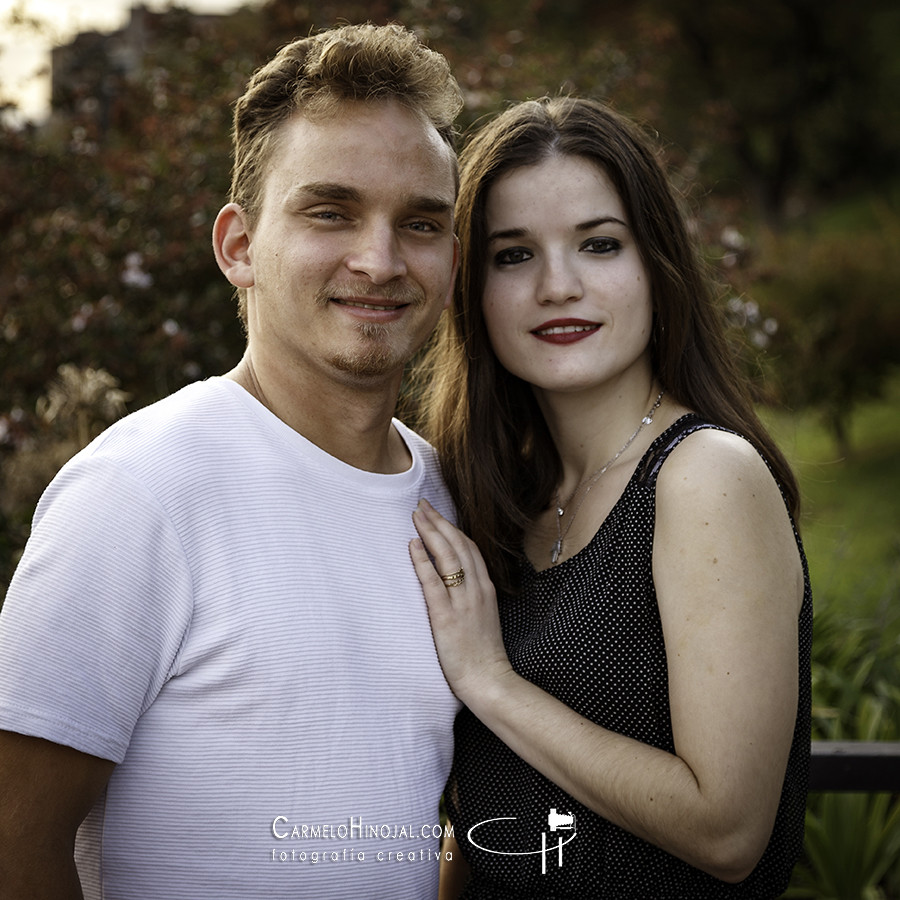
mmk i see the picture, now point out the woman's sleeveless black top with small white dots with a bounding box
[446,415,812,900]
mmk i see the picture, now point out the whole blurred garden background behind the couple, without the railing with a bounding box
[0,0,900,900]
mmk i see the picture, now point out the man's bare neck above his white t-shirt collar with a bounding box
[224,354,411,474]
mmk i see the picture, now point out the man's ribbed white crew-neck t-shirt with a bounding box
[0,378,458,900]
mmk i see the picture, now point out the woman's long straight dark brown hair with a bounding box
[415,97,799,590]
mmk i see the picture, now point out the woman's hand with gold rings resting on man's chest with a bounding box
[409,500,512,703]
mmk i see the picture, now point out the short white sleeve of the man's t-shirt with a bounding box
[0,454,192,762]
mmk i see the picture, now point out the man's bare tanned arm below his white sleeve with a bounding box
[0,731,115,900]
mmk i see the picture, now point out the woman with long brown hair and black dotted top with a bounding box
[410,99,812,900]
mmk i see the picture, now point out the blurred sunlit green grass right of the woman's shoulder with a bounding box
[764,376,900,623]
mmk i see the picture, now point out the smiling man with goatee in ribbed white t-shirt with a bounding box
[0,26,460,900]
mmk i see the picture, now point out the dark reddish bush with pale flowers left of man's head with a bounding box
[0,12,260,424]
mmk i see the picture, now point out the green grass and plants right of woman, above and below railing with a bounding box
[764,388,900,900]
